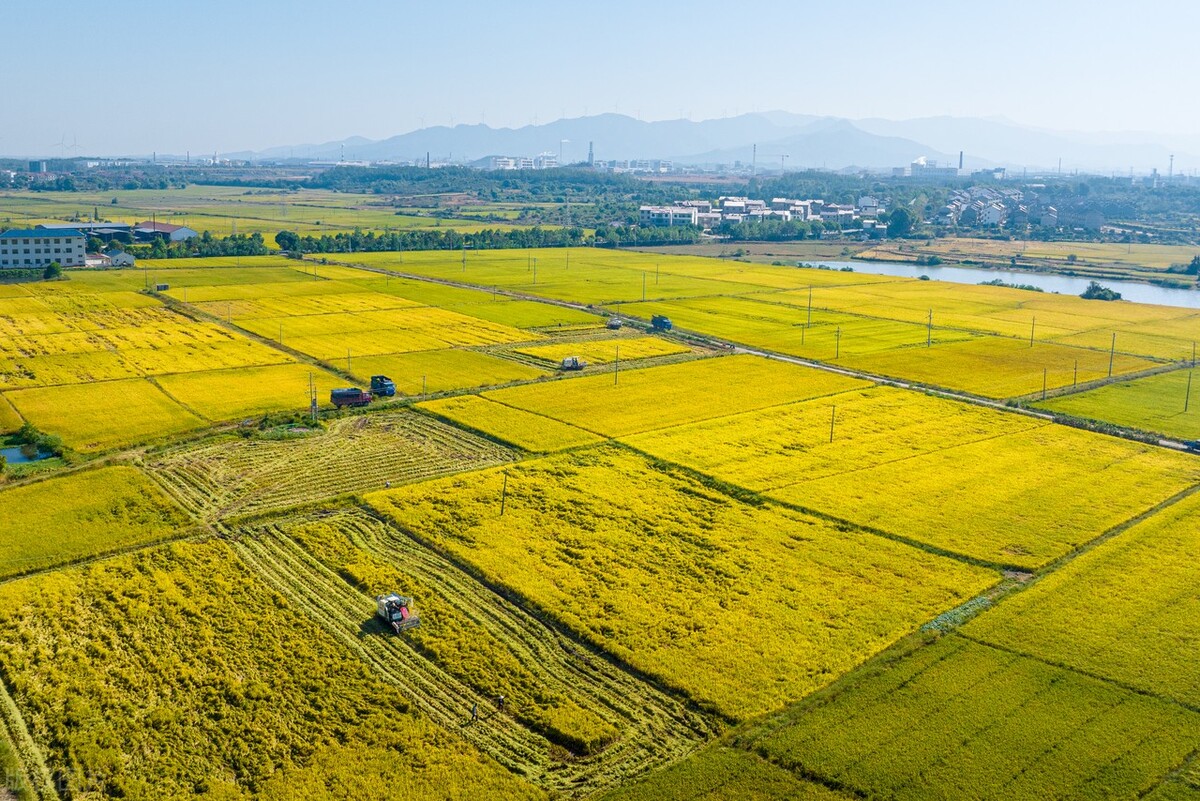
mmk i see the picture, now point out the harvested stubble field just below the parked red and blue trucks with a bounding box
[149,410,512,518]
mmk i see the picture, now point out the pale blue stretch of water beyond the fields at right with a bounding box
[808,261,1200,308]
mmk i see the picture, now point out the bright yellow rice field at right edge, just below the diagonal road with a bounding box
[770,426,1200,567]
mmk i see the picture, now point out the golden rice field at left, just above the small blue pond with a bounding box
[5,379,204,453]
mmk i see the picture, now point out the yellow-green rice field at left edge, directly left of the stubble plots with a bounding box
[0,466,193,578]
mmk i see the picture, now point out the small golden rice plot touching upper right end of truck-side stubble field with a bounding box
[418,395,601,453]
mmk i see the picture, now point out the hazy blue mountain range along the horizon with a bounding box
[231,112,1200,174]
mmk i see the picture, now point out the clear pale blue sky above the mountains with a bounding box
[0,0,1200,156]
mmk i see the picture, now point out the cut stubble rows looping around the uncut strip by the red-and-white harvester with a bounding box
[231,513,707,791]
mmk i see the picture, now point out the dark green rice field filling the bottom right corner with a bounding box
[743,636,1200,799]
